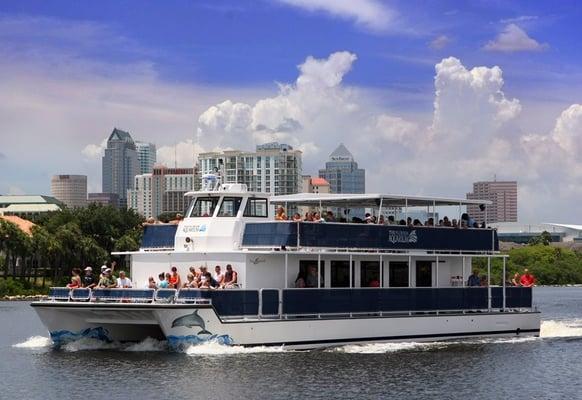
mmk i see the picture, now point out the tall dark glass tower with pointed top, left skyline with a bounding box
[102,128,140,207]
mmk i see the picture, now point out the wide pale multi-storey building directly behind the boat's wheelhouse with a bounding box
[198,142,302,195]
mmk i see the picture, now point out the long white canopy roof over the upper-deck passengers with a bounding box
[271,193,492,208]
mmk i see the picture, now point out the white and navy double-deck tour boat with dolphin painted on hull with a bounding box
[32,175,540,349]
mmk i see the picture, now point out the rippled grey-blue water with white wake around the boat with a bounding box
[0,288,582,400]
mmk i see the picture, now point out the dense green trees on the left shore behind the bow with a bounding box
[0,204,144,294]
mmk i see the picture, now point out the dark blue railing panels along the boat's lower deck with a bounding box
[44,287,532,317]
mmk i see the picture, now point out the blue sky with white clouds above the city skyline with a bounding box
[0,0,582,224]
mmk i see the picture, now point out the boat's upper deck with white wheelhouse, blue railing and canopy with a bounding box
[135,181,499,254]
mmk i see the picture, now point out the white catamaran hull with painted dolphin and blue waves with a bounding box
[32,302,540,349]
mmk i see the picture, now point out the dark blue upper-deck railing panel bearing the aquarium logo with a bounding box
[242,222,499,252]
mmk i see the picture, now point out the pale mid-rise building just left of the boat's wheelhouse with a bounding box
[127,165,197,218]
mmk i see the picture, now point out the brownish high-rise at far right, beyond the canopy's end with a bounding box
[467,180,517,224]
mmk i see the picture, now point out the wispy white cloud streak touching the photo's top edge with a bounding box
[278,0,396,32]
